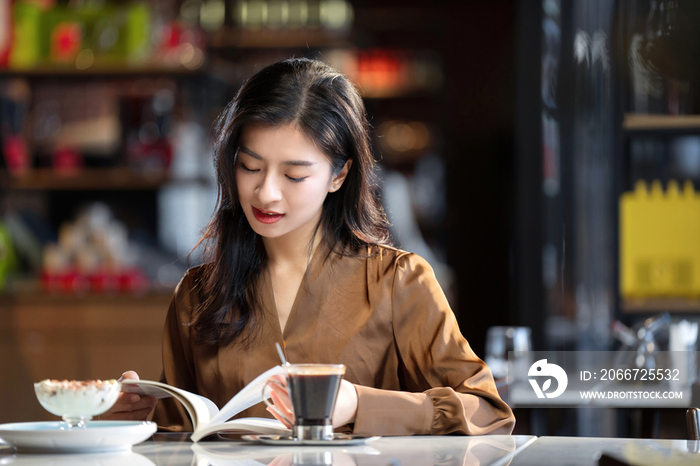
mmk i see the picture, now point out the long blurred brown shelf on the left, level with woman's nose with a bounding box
[0,168,206,191]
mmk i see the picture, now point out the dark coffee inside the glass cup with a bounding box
[288,374,343,426]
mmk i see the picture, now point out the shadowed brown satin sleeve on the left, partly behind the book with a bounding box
[153,269,197,432]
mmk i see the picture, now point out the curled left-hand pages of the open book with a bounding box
[122,380,219,430]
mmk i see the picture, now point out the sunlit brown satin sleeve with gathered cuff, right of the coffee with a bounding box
[354,254,515,435]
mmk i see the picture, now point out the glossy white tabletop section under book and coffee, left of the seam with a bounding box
[0,434,537,466]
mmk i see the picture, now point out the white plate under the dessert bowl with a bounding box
[0,421,158,453]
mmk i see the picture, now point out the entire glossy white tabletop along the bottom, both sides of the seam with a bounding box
[0,434,700,466]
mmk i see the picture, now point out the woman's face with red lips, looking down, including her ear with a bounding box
[236,125,351,242]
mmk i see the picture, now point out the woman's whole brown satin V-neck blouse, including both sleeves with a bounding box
[154,242,515,435]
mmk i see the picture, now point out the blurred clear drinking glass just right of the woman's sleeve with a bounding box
[484,327,532,382]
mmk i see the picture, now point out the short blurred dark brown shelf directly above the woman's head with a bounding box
[209,28,352,49]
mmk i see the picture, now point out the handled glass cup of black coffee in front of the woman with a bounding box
[263,364,345,440]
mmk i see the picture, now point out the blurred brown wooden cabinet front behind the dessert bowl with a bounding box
[0,284,170,422]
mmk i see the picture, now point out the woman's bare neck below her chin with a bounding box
[263,224,322,270]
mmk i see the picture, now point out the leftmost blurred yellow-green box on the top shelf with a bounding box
[9,1,42,69]
